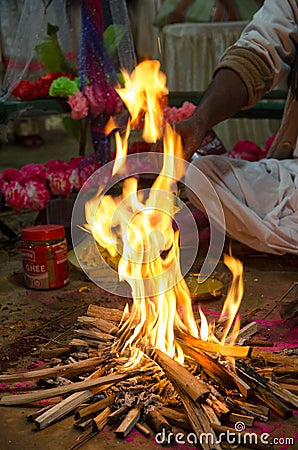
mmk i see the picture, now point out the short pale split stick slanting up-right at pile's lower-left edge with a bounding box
[34,390,93,430]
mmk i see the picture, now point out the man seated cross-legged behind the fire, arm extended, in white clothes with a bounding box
[176,0,298,254]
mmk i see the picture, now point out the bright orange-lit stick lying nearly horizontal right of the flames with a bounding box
[178,335,251,358]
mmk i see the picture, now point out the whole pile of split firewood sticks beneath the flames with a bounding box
[0,305,298,450]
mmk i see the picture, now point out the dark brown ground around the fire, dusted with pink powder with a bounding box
[0,121,298,450]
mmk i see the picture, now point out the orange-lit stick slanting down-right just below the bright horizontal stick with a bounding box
[181,343,251,398]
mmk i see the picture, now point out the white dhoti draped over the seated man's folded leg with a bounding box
[185,156,298,254]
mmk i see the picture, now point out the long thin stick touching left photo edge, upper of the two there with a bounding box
[0,357,106,383]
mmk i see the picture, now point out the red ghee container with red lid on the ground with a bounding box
[21,225,69,289]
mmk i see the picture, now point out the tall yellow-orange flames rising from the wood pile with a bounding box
[86,61,242,366]
